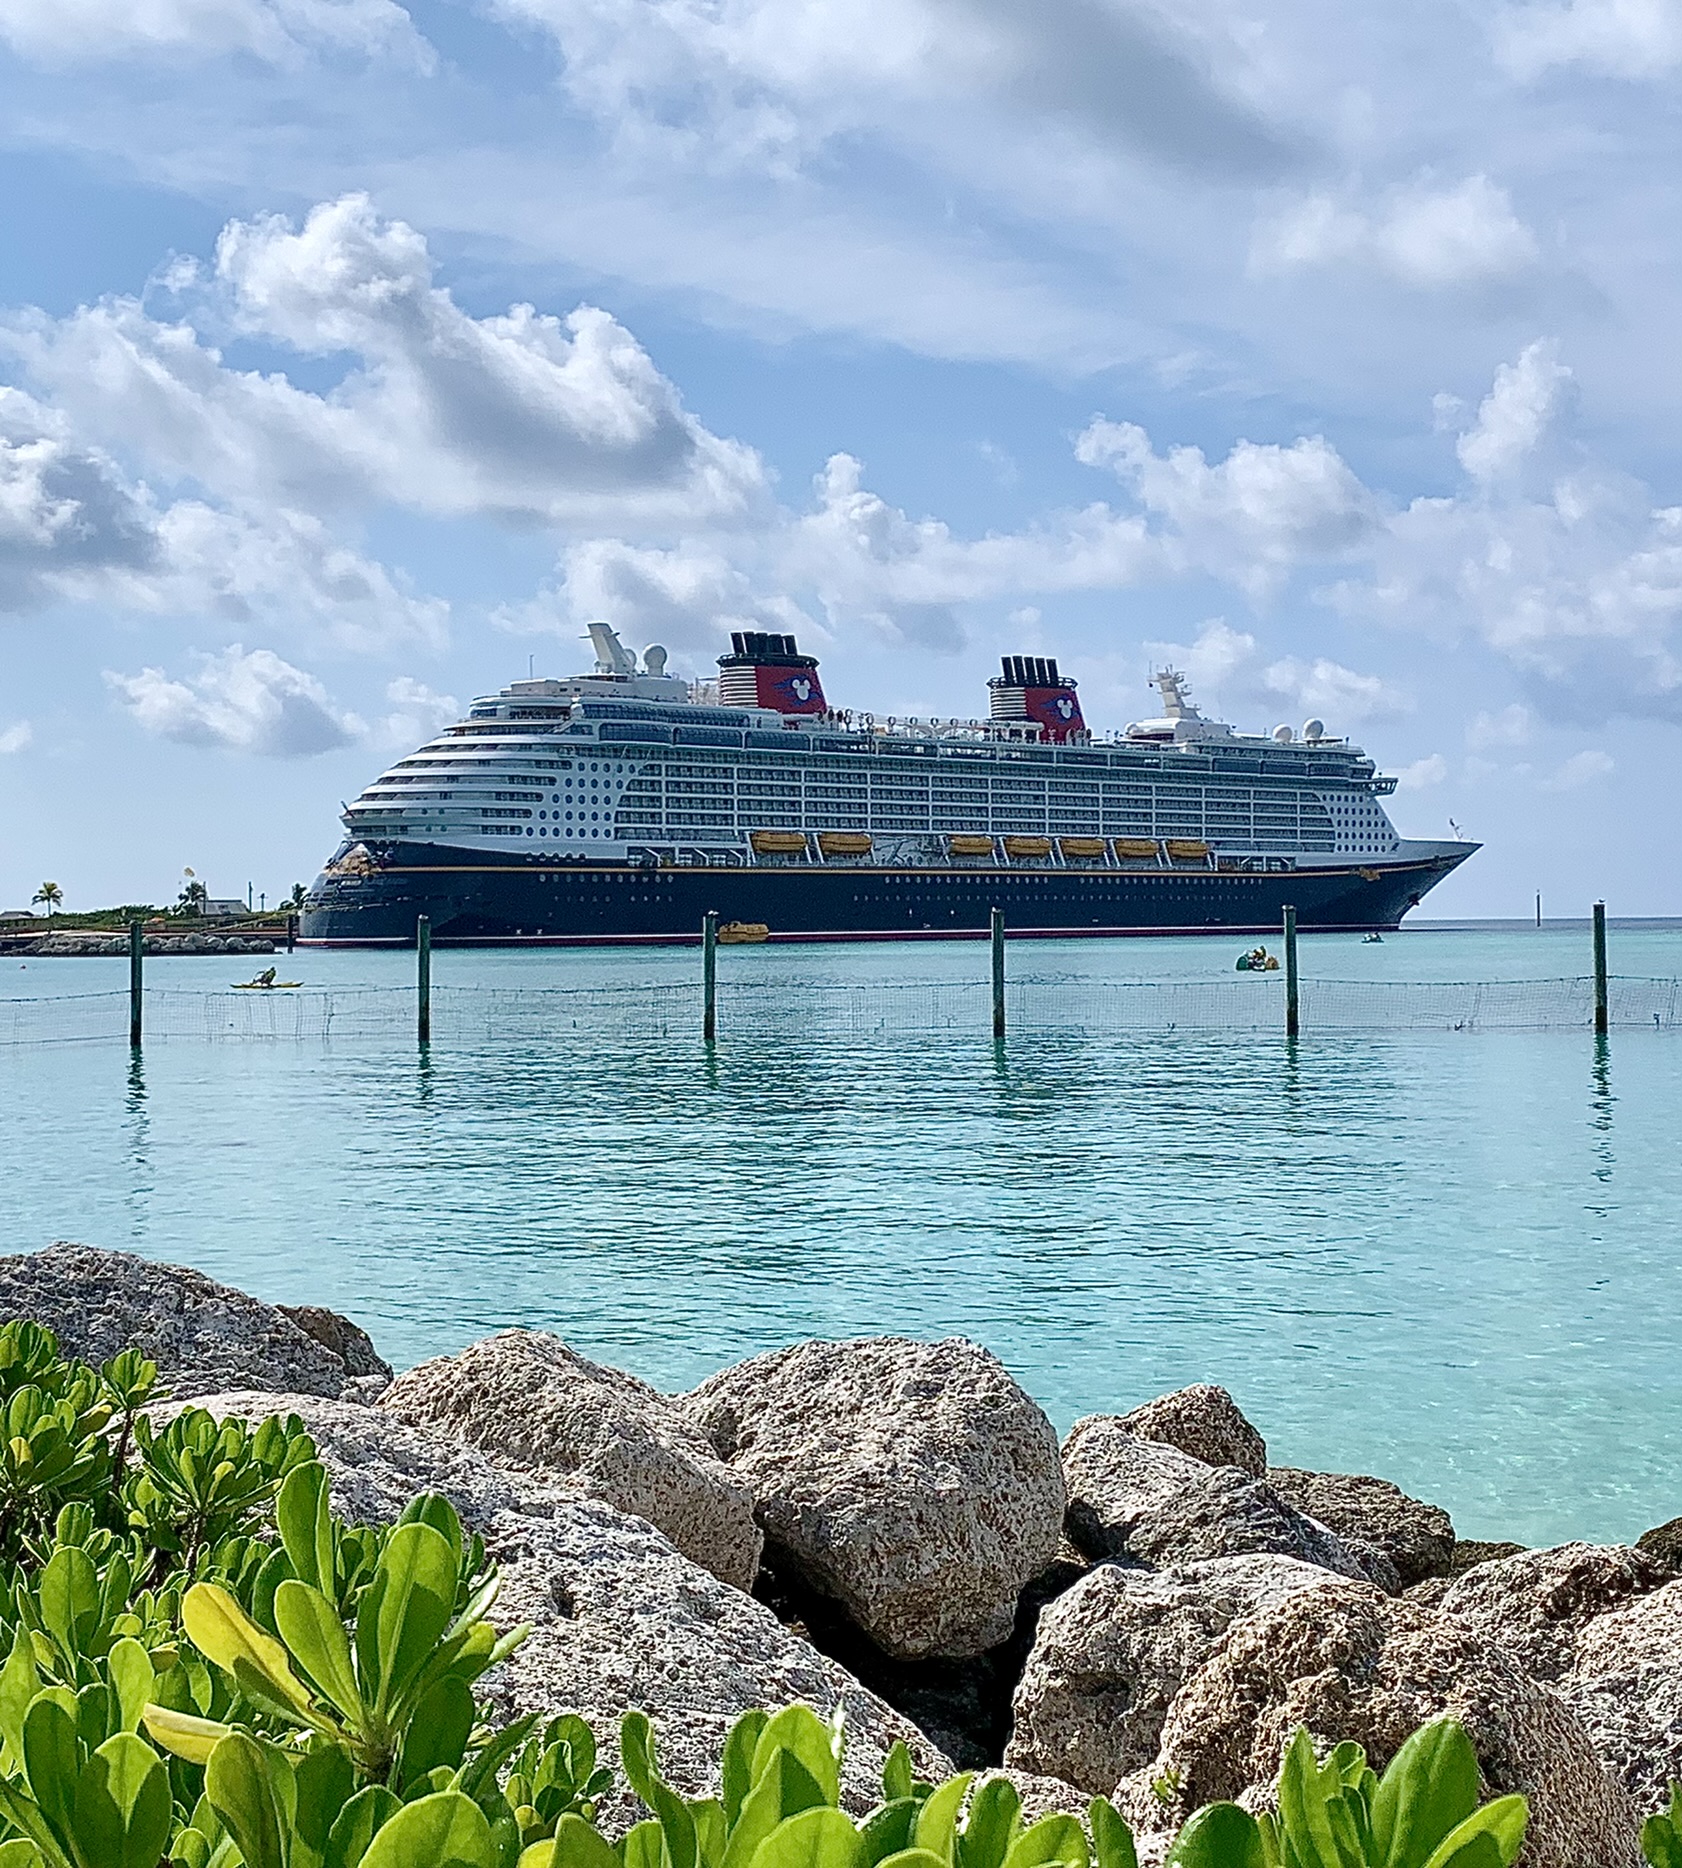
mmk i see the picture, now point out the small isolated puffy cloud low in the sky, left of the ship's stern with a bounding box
[105,643,366,758]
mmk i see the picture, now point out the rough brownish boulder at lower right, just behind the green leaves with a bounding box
[1121,1582,1641,1868]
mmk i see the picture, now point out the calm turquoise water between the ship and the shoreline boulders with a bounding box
[0,927,1682,1543]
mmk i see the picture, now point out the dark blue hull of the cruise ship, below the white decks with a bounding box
[299,844,1463,947]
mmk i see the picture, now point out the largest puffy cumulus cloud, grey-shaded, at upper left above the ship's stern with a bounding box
[4,194,766,527]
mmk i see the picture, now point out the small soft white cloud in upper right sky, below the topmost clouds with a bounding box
[1254,176,1540,291]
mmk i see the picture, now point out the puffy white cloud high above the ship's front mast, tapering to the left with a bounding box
[1075,418,1379,598]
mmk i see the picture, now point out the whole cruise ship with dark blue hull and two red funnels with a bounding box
[299,622,1476,947]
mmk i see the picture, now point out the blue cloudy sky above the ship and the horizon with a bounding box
[0,0,1682,913]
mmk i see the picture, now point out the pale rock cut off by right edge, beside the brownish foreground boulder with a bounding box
[1559,1582,1682,1814]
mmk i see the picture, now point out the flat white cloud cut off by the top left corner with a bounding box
[0,0,432,69]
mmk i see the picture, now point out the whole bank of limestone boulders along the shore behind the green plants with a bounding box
[0,1244,1682,1868]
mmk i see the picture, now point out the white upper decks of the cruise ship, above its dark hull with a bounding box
[344,624,1435,869]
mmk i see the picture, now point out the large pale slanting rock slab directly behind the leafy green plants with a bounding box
[177,1392,951,1818]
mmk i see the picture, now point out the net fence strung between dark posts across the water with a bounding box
[0,973,1682,1046]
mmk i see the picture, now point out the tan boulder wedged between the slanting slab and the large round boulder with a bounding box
[379,1330,763,1590]
